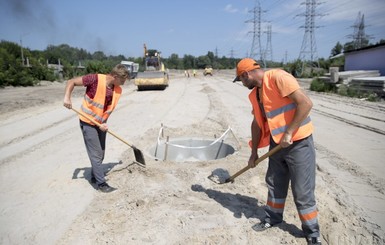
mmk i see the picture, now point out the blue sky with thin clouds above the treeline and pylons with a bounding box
[0,0,385,61]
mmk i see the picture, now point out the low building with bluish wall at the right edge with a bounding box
[344,43,385,76]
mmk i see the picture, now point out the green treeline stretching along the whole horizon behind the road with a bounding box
[0,40,384,87]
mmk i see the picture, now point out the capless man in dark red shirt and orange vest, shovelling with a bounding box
[63,64,129,193]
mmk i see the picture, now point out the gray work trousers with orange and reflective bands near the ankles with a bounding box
[265,135,320,237]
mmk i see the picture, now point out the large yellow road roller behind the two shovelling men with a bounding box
[135,44,169,91]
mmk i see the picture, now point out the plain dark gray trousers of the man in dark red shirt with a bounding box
[80,121,107,185]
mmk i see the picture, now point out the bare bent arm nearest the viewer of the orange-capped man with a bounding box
[281,89,313,147]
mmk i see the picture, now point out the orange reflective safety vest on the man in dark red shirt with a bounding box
[79,74,122,125]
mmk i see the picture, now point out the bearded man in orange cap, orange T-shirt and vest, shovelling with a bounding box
[234,58,321,244]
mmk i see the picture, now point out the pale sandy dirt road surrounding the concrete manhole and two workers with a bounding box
[0,72,385,244]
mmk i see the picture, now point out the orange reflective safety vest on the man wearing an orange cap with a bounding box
[249,71,313,147]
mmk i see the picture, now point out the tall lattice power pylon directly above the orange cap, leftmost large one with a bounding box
[245,1,265,65]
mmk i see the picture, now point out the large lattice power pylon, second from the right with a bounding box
[298,0,323,67]
